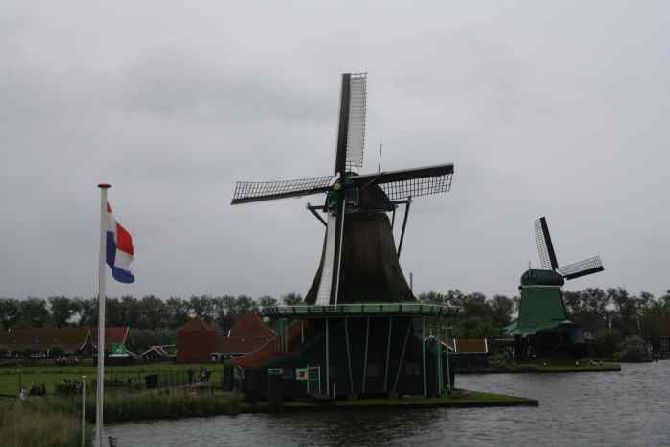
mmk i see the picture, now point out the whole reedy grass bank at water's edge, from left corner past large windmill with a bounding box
[0,388,538,447]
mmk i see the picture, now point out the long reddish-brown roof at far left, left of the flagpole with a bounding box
[0,327,90,352]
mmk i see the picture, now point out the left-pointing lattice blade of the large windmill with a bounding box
[231,176,333,205]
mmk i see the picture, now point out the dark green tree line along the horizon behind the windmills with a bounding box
[0,288,670,343]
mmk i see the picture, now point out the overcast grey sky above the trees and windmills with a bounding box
[0,0,670,298]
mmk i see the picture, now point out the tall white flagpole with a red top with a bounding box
[94,183,111,447]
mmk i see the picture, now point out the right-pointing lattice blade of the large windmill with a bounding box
[352,163,454,200]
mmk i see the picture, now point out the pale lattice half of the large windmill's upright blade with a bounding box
[347,73,367,171]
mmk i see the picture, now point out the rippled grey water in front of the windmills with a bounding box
[107,360,670,447]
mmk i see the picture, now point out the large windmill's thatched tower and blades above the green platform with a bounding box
[231,73,454,305]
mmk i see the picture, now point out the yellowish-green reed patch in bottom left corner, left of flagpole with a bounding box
[0,399,92,447]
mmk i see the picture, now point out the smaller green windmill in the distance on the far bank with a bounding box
[505,217,605,358]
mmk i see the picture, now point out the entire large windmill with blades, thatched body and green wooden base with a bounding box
[230,73,454,398]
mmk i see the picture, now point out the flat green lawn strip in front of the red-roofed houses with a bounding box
[0,363,222,394]
